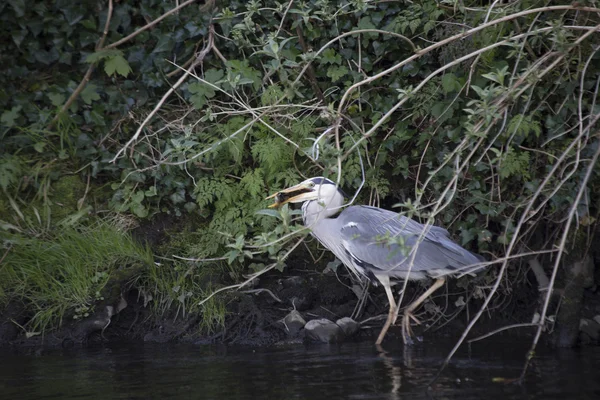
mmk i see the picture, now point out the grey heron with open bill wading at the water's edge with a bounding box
[267,177,483,344]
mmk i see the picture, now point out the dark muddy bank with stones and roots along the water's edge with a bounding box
[0,260,600,347]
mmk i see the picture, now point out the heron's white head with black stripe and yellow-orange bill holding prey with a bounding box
[267,177,345,208]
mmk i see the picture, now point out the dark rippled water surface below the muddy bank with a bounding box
[0,341,600,400]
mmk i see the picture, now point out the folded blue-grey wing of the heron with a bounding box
[337,206,481,279]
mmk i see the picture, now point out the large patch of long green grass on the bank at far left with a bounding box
[0,224,153,335]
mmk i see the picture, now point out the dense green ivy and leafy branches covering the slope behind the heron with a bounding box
[0,0,600,360]
